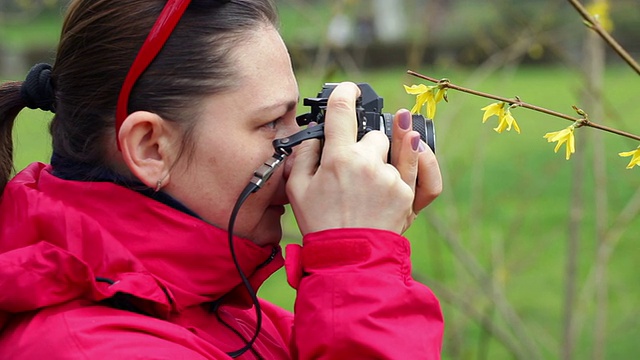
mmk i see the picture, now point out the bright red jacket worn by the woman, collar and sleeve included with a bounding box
[0,163,443,359]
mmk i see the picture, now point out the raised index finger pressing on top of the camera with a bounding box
[324,82,360,152]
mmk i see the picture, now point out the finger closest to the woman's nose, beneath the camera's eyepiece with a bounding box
[287,139,321,195]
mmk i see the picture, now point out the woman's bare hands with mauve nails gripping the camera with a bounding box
[287,83,442,235]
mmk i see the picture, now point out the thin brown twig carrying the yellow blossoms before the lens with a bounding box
[407,70,640,141]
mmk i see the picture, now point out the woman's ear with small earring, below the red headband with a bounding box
[118,111,176,190]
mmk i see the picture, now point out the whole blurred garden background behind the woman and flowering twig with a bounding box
[0,0,640,359]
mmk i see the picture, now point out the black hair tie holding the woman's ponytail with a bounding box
[20,64,56,112]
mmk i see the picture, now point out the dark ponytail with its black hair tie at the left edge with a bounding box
[0,64,55,197]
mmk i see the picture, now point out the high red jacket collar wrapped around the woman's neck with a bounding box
[0,163,283,318]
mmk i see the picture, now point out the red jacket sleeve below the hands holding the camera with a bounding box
[286,229,444,359]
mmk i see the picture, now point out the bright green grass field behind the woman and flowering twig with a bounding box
[10,63,640,359]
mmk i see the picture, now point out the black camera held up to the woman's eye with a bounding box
[296,83,436,153]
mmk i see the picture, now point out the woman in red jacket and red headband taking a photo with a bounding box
[0,0,443,359]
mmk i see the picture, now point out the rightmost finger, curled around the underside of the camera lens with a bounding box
[413,143,442,214]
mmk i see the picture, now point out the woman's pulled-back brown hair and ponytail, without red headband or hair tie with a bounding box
[0,0,277,192]
